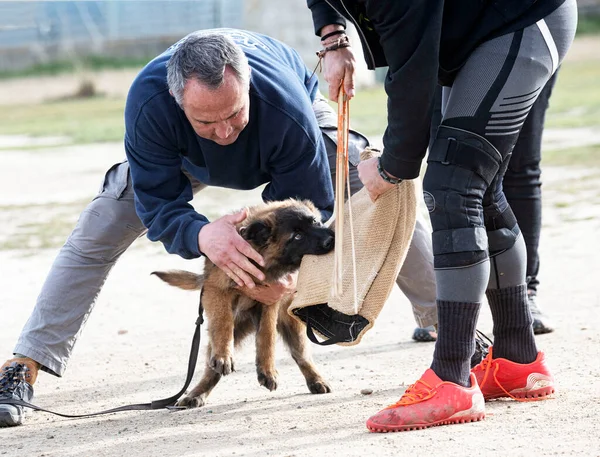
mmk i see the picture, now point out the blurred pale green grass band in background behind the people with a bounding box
[0,39,600,151]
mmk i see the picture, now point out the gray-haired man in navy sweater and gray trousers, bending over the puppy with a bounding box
[0,29,435,426]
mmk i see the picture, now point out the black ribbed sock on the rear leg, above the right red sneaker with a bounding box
[485,284,538,363]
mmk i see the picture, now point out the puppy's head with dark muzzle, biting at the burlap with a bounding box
[240,199,334,278]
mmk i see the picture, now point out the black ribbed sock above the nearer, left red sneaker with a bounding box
[431,300,481,387]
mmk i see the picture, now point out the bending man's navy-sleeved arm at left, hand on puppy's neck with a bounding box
[125,106,264,288]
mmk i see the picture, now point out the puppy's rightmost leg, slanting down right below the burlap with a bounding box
[277,312,331,394]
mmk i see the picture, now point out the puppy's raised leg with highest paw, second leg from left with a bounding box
[202,286,235,375]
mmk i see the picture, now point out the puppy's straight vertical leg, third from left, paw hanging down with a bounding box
[256,305,278,391]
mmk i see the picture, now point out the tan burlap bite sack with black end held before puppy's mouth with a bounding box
[288,180,417,346]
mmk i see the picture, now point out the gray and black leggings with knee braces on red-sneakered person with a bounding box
[423,0,577,303]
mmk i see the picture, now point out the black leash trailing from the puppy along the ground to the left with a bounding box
[0,294,204,419]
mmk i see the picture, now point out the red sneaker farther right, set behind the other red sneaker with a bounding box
[471,348,556,401]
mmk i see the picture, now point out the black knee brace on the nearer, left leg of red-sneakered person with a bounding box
[423,125,505,268]
